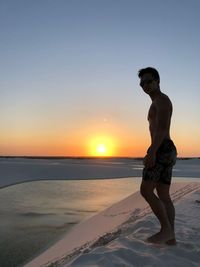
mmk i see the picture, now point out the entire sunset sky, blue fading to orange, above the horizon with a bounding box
[0,0,200,157]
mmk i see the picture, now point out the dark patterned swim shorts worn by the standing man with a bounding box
[142,139,177,185]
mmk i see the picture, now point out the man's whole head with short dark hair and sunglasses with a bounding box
[138,67,160,95]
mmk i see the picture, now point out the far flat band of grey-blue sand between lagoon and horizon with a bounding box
[0,158,200,188]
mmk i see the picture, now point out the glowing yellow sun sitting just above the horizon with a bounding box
[89,137,114,157]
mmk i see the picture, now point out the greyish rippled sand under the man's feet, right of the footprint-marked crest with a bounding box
[69,184,200,267]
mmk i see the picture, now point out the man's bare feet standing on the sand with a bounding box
[147,231,176,245]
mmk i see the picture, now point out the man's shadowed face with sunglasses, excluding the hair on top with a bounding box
[140,73,159,95]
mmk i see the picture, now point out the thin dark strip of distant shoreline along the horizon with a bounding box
[0,156,200,160]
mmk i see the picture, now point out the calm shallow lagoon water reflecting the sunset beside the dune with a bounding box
[0,178,140,267]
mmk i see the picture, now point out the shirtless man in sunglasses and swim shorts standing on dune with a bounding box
[138,67,177,245]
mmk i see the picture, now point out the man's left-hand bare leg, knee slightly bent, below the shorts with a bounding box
[140,180,174,243]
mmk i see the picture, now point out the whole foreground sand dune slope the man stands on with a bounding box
[26,182,200,267]
